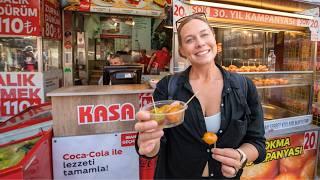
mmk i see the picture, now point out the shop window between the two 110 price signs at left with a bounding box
[0,37,39,72]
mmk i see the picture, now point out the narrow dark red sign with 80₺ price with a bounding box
[42,0,62,39]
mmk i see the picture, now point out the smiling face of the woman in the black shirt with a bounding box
[179,19,217,65]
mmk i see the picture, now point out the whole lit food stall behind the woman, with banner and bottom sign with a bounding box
[173,0,319,179]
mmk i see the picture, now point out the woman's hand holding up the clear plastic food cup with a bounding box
[135,111,164,157]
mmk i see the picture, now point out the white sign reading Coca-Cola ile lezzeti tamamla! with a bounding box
[52,132,139,179]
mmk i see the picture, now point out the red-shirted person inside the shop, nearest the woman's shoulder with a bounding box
[147,46,171,74]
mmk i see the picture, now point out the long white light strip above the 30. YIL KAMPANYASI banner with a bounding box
[183,0,314,19]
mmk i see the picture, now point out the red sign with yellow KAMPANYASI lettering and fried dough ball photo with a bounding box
[241,131,318,180]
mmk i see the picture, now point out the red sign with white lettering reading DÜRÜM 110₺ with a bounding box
[0,0,41,36]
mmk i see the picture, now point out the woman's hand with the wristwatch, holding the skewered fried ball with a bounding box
[211,148,242,178]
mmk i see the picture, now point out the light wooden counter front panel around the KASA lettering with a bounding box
[52,93,139,137]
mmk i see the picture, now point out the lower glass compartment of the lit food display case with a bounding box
[241,71,313,121]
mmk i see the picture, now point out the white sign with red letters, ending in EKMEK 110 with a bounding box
[0,72,44,119]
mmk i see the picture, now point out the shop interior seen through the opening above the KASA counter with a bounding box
[73,12,172,85]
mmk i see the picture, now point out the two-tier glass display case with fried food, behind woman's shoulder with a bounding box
[215,28,316,131]
